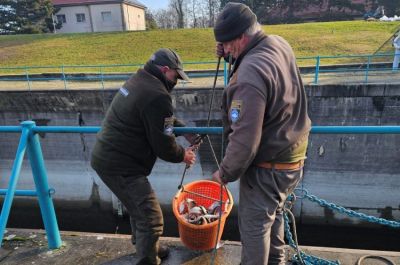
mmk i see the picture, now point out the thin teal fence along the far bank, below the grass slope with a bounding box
[0,53,400,91]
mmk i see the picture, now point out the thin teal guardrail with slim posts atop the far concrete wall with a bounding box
[0,53,400,90]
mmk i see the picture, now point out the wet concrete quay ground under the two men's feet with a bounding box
[0,229,400,265]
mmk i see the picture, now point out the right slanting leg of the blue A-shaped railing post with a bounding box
[22,121,62,249]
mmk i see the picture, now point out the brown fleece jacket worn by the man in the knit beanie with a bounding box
[221,33,311,181]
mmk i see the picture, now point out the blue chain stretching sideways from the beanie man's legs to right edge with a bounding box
[296,189,400,228]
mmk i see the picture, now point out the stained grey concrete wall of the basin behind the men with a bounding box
[0,85,400,225]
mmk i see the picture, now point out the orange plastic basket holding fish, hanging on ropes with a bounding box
[172,180,233,250]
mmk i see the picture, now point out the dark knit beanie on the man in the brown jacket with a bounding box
[214,2,257,42]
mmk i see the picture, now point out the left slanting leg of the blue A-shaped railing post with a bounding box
[0,120,30,246]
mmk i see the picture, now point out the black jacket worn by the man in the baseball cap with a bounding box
[91,69,184,176]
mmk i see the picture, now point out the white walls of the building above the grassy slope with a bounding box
[52,0,146,33]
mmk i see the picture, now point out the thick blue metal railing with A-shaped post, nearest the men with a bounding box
[0,121,400,249]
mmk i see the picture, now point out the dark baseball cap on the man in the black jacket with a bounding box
[150,48,189,81]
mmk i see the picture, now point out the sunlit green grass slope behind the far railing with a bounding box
[0,21,400,67]
